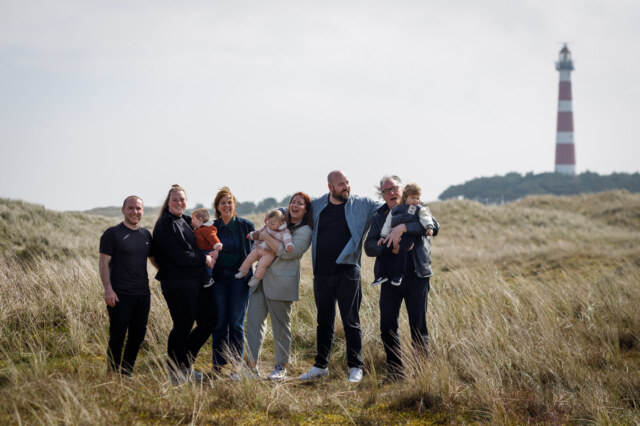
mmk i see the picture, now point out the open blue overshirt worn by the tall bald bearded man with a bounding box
[311,194,380,270]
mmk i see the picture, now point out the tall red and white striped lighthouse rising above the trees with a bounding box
[556,43,576,175]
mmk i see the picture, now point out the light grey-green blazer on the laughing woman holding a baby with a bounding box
[252,225,312,301]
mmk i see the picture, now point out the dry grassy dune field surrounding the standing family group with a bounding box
[0,192,640,424]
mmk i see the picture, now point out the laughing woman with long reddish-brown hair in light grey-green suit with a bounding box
[247,192,313,380]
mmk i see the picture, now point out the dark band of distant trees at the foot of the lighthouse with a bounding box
[438,171,640,204]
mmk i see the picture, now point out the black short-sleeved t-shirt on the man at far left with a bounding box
[100,223,152,296]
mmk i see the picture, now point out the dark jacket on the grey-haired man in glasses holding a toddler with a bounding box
[364,204,440,278]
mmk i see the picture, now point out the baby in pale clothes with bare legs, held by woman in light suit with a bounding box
[236,209,293,287]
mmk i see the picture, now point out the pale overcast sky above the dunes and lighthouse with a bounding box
[0,0,640,210]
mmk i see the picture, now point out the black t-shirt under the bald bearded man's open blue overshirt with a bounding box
[314,202,351,275]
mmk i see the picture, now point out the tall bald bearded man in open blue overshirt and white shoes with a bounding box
[300,170,402,383]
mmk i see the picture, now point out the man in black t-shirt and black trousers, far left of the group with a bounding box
[99,195,154,375]
